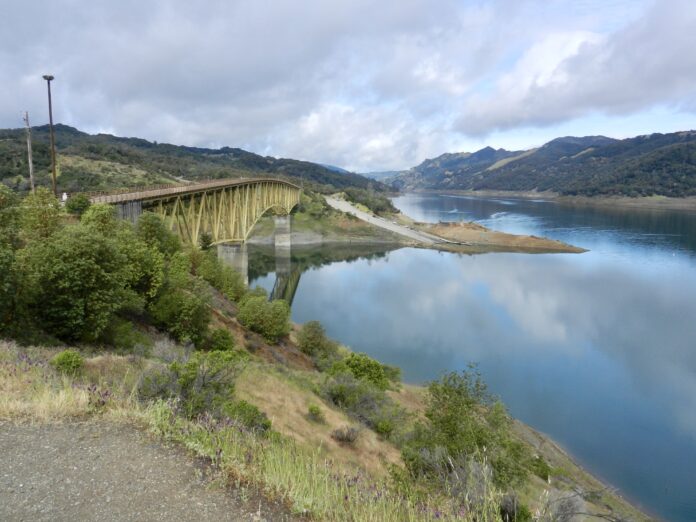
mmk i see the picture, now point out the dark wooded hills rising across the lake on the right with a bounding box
[392,131,696,197]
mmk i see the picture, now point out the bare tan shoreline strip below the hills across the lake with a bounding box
[410,189,696,212]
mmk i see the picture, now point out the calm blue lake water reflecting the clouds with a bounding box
[250,195,696,521]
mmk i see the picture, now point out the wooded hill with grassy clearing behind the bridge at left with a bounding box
[0,124,386,192]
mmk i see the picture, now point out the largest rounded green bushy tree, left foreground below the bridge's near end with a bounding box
[18,225,129,341]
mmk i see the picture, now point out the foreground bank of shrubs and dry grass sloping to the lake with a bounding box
[0,185,640,521]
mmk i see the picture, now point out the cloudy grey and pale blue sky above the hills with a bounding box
[0,0,696,172]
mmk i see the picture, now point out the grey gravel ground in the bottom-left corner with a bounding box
[0,421,291,522]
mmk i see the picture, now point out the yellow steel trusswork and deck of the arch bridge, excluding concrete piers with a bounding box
[90,178,302,245]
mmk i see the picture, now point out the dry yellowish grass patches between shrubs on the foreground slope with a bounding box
[0,340,646,521]
